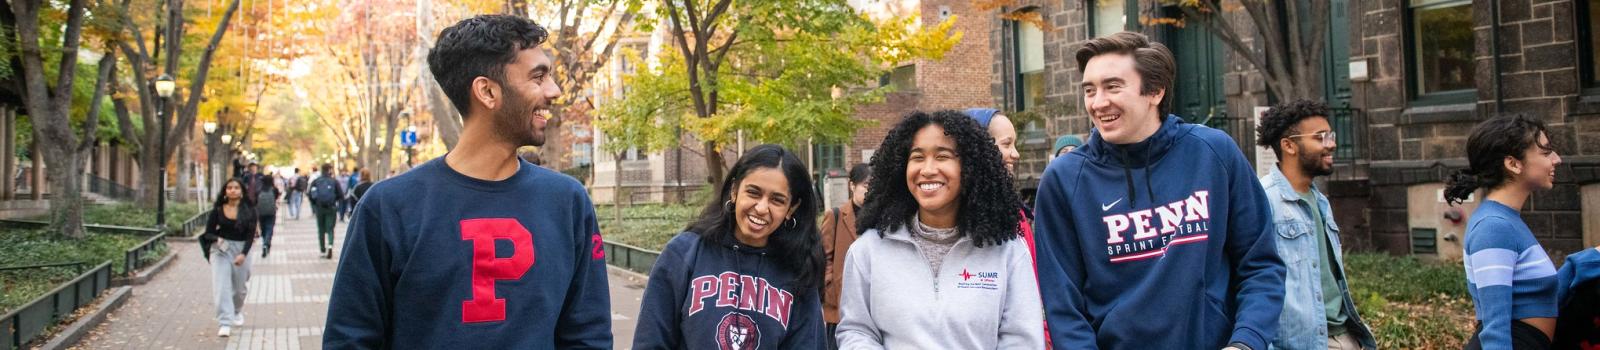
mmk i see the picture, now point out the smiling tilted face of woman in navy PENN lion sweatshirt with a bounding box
[730,168,798,246]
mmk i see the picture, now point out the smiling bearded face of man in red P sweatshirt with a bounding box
[485,48,562,145]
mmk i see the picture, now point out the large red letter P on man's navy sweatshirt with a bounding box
[461,219,533,323]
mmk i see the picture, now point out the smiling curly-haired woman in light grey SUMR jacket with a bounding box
[838,110,1045,348]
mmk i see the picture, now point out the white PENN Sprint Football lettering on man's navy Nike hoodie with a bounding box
[1101,190,1211,262]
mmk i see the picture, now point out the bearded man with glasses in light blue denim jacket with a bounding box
[1256,101,1378,350]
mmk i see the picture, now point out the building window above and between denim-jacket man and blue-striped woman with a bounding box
[1410,0,1477,99]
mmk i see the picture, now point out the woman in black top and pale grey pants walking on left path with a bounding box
[200,179,258,337]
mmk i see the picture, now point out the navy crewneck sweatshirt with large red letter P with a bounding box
[323,157,611,348]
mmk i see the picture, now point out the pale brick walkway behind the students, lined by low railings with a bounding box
[74,209,645,350]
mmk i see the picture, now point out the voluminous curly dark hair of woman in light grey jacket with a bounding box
[856,110,1021,248]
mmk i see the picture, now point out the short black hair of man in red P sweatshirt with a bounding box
[427,14,549,118]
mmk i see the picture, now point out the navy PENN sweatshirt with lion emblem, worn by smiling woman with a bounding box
[634,232,824,350]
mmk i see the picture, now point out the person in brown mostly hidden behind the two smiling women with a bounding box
[821,165,872,350]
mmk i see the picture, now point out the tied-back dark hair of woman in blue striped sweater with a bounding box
[1445,113,1549,205]
